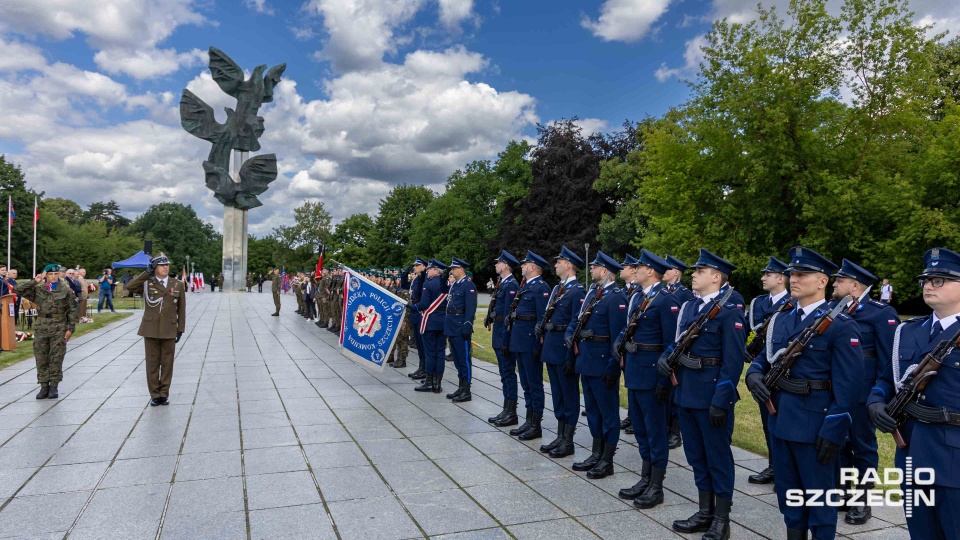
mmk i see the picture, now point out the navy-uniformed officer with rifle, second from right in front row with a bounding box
[746,246,864,540]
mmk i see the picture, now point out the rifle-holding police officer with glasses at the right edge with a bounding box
[867,248,960,540]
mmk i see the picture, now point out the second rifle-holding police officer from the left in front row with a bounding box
[506,250,550,441]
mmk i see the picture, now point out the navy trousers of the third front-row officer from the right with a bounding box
[677,407,740,500]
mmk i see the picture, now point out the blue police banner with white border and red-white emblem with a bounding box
[340,270,407,373]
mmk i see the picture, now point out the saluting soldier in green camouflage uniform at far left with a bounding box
[17,264,79,399]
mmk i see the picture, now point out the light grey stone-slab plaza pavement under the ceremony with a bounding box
[0,293,908,540]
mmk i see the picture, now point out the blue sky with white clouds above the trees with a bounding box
[0,0,960,236]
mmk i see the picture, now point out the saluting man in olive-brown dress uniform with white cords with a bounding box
[127,253,187,407]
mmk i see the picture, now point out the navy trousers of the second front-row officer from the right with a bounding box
[768,436,836,540]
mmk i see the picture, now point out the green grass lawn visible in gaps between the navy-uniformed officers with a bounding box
[473,308,897,487]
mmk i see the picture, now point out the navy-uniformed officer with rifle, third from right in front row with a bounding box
[657,249,746,540]
